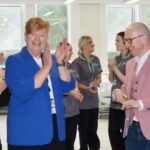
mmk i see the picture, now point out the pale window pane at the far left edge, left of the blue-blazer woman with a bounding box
[0,6,22,52]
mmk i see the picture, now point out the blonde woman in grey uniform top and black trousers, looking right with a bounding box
[72,36,102,150]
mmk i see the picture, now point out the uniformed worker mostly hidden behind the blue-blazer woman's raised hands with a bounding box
[63,43,83,150]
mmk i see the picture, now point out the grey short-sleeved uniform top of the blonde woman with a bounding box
[72,55,102,109]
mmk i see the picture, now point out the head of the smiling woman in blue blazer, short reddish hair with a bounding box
[25,17,49,57]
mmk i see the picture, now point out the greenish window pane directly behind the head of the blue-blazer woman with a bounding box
[37,5,68,50]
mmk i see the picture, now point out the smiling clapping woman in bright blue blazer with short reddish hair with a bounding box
[6,17,75,150]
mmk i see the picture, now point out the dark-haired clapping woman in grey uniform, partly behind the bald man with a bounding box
[108,32,132,150]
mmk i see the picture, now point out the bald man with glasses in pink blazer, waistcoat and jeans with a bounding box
[113,22,150,150]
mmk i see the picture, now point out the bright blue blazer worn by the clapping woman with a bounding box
[6,47,75,146]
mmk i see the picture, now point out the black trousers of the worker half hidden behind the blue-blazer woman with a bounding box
[66,115,78,150]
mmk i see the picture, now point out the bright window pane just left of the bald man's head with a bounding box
[107,7,133,56]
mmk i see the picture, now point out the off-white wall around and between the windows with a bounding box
[0,0,150,72]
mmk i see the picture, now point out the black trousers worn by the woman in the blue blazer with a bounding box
[8,115,66,150]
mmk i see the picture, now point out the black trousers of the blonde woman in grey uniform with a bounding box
[79,108,100,150]
